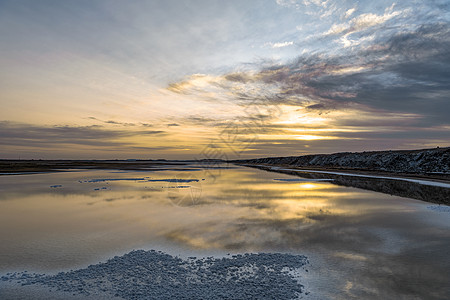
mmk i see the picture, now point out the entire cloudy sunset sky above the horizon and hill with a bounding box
[0,0,450,159]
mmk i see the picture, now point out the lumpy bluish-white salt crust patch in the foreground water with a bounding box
[1,250,308,299]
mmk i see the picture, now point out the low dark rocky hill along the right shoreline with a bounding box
[235,147,450,174]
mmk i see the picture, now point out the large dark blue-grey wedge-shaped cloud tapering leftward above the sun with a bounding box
[207,23,450,126]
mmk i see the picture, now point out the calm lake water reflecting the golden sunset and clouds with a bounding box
[0,165,450,299]
